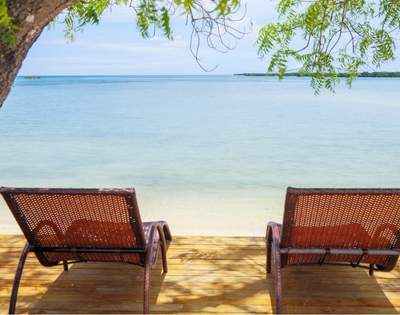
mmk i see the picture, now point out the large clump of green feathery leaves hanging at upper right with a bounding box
[257,0,400,92]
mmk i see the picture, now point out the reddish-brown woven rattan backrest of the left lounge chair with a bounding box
[0,188,145,248]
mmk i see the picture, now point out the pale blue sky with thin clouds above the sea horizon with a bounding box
[19,0,400,75]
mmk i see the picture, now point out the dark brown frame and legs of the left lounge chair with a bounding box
[0,187,172,314]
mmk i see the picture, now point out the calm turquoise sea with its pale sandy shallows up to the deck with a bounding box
[0,76,400,235]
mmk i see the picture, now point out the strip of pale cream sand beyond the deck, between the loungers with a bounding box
[0,189,284,237]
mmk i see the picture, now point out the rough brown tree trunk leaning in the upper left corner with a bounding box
[0,0,79,107]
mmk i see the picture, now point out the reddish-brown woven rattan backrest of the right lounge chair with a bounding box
[281,188,400,249]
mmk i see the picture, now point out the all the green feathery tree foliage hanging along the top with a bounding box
[0,0,400,93]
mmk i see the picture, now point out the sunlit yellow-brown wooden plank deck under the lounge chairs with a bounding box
[0,235,400,313]
